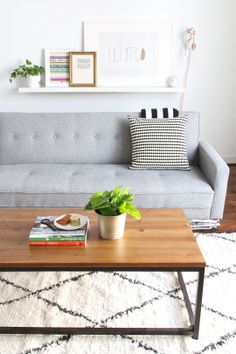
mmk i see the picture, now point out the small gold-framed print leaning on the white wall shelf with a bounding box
[70,52,96,87]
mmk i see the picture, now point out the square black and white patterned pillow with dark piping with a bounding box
[128,117,190,170]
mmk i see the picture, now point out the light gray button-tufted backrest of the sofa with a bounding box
[0,112,198,164]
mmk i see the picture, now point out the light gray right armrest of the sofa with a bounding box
[198,142,229,219]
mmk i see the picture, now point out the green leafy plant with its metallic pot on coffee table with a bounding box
[85,186,141,239]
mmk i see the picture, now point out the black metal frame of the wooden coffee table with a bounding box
[0,267,205,339]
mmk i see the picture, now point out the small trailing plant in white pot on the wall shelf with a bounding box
[9,59,45,87]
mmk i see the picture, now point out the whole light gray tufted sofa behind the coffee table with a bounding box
[0,112,229,219]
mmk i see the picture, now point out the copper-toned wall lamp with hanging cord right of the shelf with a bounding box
[179,27,196,111]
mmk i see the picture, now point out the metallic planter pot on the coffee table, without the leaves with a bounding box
[97,213,126,240]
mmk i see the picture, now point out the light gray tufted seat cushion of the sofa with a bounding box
[0,164,213,217]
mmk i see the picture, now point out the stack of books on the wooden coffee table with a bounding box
[29,216,89,246]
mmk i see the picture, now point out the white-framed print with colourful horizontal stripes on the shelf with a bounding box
[44,48,75,87]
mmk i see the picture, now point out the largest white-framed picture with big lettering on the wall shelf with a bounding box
[84,22,173,86]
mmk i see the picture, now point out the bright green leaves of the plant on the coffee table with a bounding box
[85,186,141,220]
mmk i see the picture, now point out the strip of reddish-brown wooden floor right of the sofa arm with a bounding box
[217,164,236,232]
